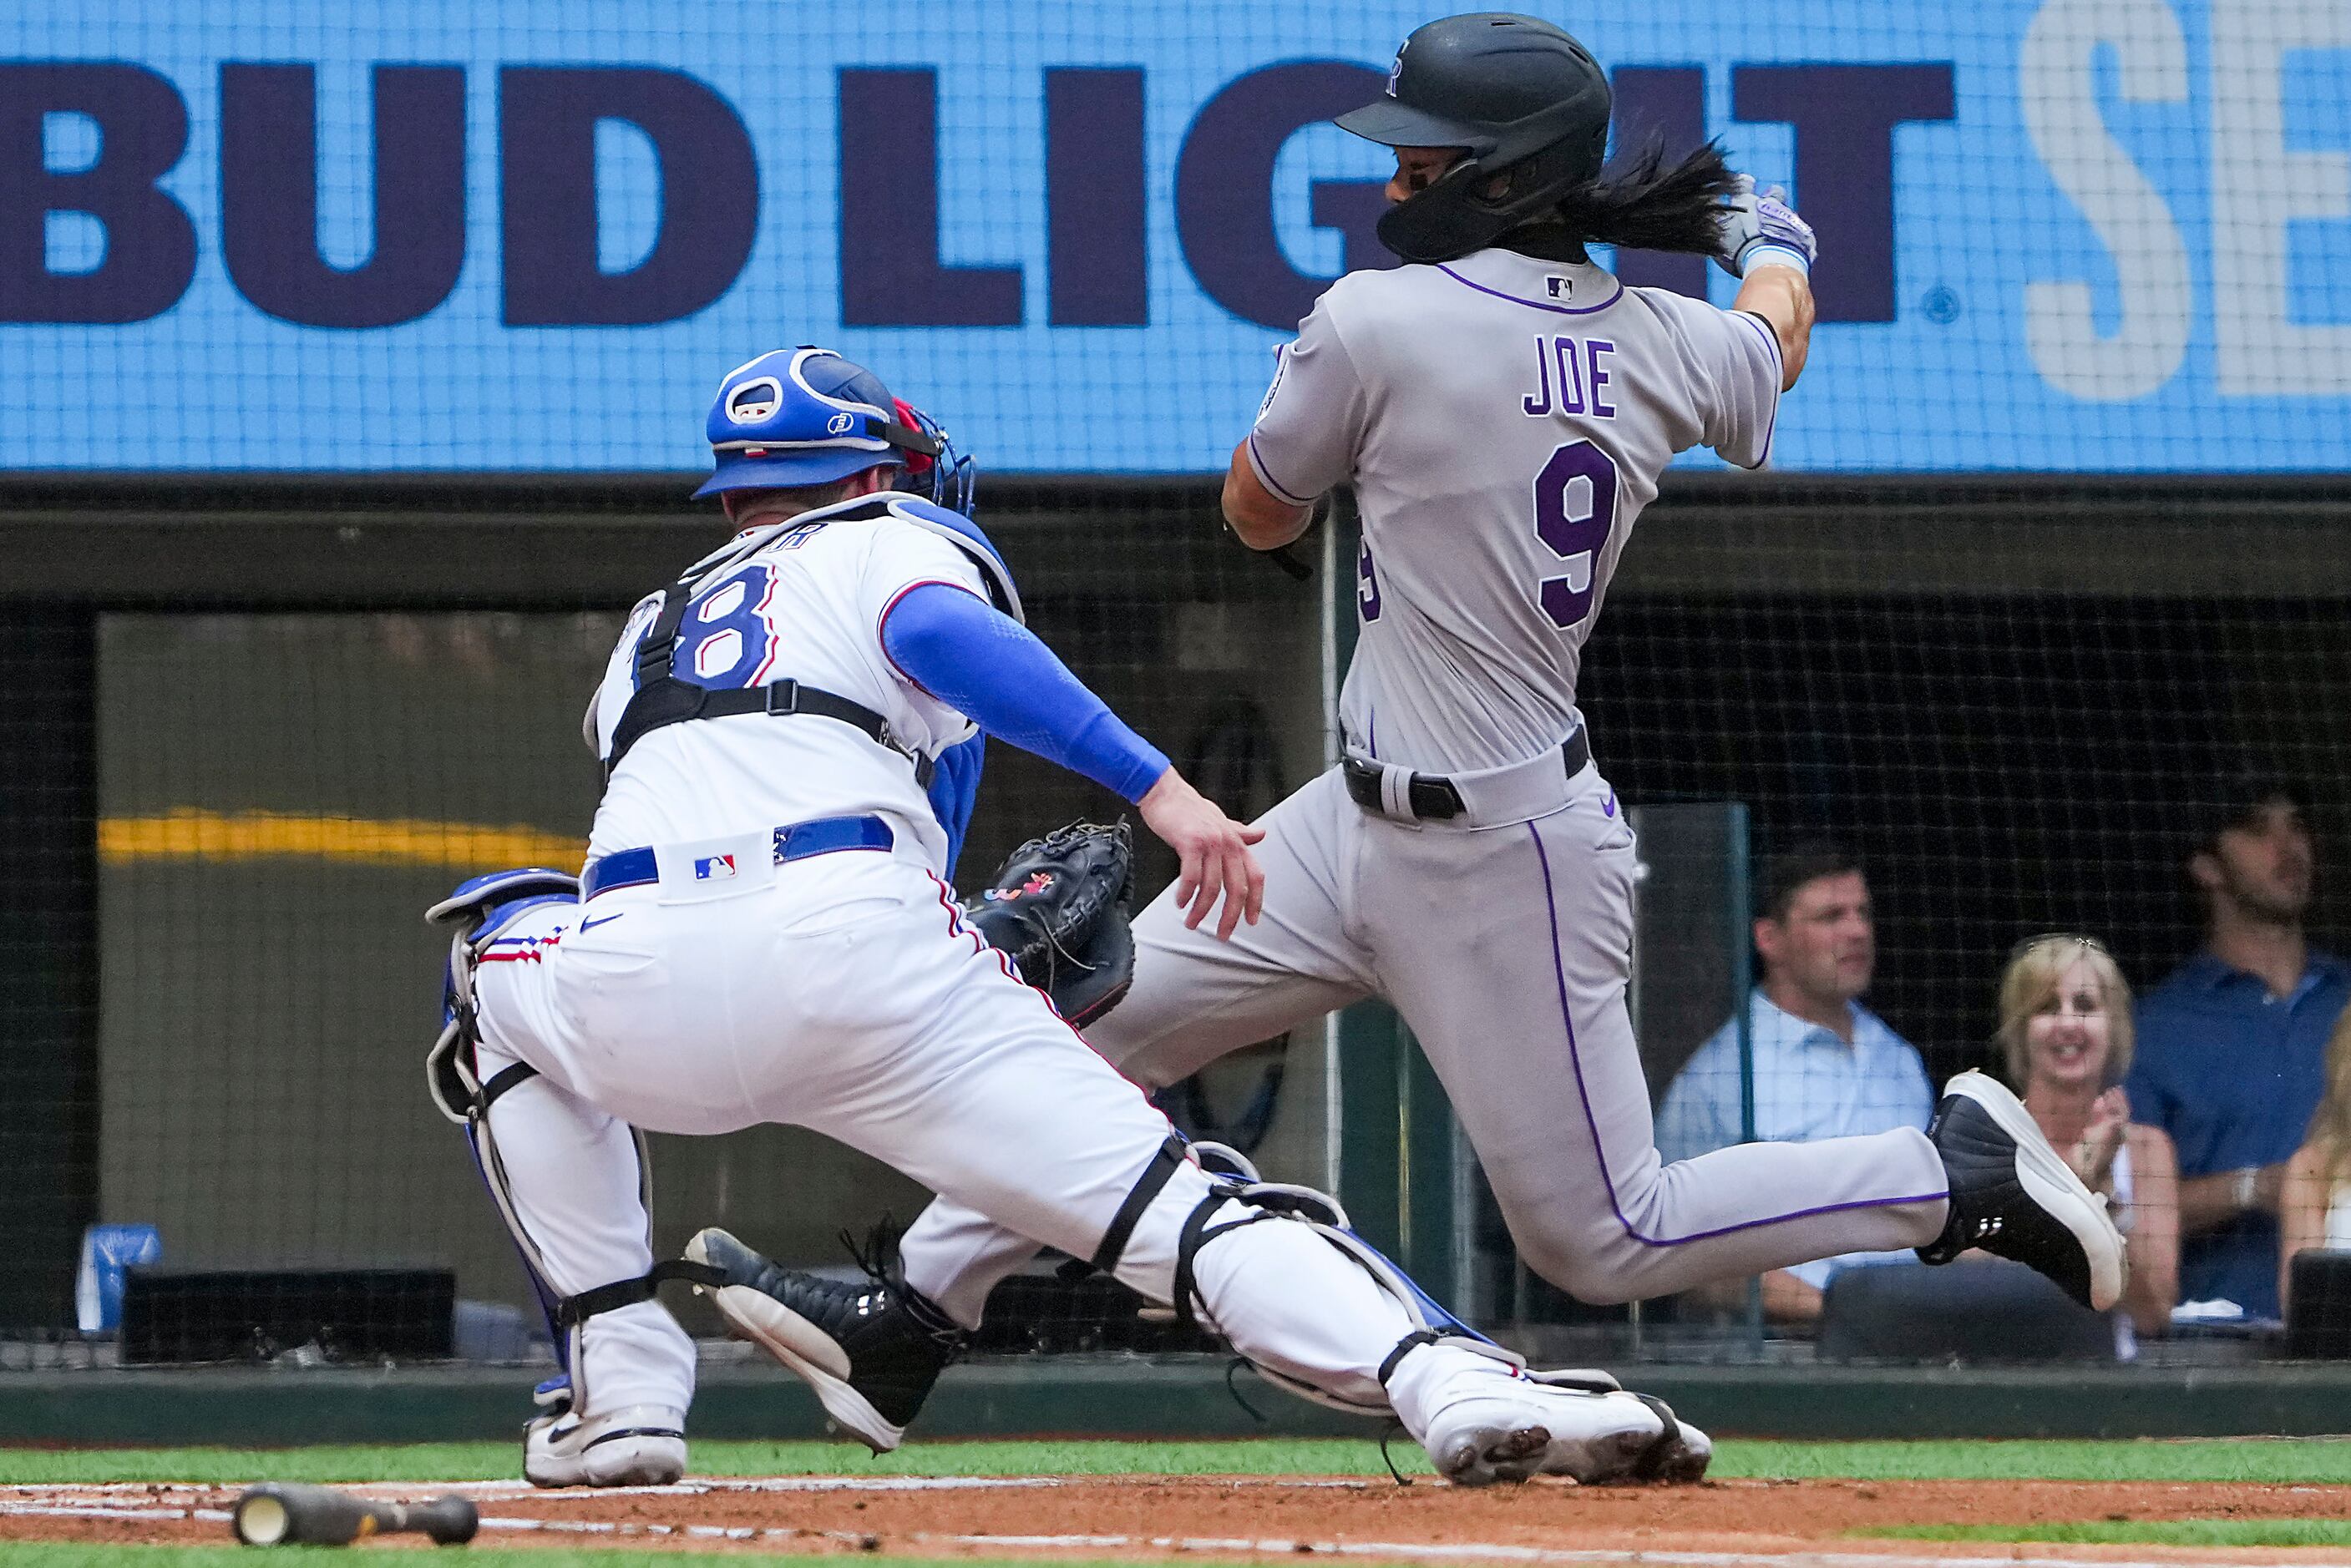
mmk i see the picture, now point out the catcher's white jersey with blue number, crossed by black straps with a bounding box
[588,498,987,870]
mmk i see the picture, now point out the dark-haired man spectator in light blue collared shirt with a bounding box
[1658,844,1935,1323]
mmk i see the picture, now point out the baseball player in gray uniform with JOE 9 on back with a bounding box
[776,14,2123,1457]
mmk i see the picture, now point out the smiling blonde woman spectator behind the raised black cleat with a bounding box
[2001,936,2180,1358]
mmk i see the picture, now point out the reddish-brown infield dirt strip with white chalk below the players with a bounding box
[0,1476,2351,1563]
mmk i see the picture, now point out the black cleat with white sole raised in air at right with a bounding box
[1918,1072,2123,1312]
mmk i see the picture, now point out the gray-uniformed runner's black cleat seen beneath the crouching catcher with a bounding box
[687,1225,964,1453]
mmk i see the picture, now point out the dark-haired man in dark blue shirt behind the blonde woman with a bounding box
[2128,783,2351,1319]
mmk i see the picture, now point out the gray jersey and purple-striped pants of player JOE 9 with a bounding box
[884,249,1947,1323]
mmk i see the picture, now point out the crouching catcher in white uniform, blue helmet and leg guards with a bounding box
[433,348,1710,1485]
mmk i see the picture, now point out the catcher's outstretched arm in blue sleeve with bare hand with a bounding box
[882,583,1264,938]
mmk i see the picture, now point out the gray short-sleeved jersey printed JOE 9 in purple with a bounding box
[1249,249,1780,771]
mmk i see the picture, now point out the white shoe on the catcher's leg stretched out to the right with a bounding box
[1390,1347,1664,1485]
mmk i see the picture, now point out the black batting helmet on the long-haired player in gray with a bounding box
[1335,12,1610,261]
